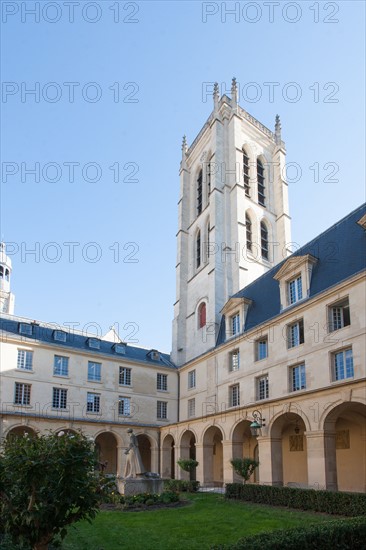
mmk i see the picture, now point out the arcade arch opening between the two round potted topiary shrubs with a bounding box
[202,426,224,487]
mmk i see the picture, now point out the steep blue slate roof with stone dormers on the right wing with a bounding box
[216,204,366,345]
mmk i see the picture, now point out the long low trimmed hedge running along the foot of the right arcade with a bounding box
[225,483,366,516]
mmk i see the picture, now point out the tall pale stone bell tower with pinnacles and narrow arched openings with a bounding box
[172,78,291,366]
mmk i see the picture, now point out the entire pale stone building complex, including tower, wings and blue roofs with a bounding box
[0,85,366,491]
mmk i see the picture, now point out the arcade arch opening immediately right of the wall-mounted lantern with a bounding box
[269,411,308,486]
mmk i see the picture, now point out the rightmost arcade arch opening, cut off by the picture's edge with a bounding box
[322,401,366,492]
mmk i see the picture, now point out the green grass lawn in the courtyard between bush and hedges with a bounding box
[62,493,334,550]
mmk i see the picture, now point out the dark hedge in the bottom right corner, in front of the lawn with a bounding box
[211,517,366,550]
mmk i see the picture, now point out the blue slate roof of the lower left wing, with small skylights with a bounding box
[0,317,176,369]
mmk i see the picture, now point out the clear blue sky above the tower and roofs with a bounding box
[1,0,365,351]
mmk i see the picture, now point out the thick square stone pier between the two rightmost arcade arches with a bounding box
[304,430,337,491]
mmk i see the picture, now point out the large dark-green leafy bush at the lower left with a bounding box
[0,432,102,550]
